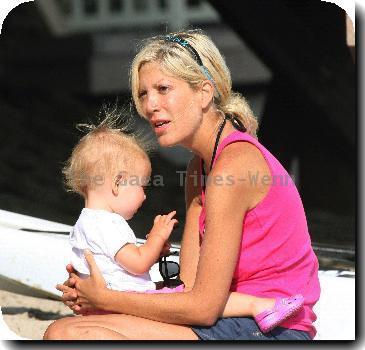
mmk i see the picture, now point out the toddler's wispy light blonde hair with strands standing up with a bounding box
[62,105,152,197]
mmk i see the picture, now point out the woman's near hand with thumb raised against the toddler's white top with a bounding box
[71,250,108,314]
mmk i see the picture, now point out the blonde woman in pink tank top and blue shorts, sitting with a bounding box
[45,31,320,340]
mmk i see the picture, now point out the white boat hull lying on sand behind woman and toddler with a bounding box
[0,210,355,340]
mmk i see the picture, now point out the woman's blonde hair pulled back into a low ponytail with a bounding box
[130,29,258,137]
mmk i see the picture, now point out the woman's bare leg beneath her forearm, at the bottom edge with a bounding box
[46,314,198,340]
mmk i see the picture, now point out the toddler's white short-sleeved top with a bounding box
[70,208,156,292]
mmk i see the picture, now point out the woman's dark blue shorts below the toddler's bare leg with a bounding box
[191,317,312,340]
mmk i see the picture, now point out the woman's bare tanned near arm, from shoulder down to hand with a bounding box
[71,143,267,325]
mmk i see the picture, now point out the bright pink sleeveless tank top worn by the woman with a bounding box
[199,131,320,338]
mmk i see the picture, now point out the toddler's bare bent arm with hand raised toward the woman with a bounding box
[115,211,177,275]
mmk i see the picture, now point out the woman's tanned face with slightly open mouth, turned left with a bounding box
[138,62,203,147]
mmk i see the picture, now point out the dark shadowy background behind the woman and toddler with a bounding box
[0,0,357,266]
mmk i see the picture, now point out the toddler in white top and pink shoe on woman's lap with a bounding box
[63,110,304,332]
